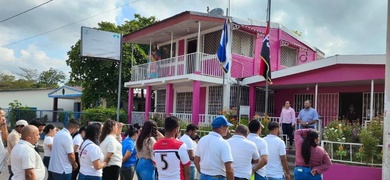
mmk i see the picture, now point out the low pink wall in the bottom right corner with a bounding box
[323,163,382,180]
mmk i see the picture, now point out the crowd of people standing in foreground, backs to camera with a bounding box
[0,105,331,180]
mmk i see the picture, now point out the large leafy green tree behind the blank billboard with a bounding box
[66,14,156,108]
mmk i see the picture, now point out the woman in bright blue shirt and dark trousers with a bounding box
[121,125,138,180]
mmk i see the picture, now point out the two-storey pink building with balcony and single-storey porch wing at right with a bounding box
[124,11,385,127]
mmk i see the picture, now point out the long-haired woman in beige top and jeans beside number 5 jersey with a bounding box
[135,121,157,180]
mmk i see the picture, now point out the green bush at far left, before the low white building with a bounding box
[7,100,37,127]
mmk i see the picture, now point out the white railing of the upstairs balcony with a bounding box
[131,52,223,81]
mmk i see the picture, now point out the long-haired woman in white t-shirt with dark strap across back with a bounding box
[78,123,106,180]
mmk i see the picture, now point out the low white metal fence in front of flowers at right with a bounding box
[321,140,382,166]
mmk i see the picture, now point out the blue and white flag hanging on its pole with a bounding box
[217,20,231,73]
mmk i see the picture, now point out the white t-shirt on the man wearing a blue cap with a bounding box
[195,132,233,176]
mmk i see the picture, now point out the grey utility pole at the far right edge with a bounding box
[382,0,390,180]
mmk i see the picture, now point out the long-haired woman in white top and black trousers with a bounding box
[100,119,123,180]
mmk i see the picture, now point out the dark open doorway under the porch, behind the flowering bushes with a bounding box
[339,93,363,121]
